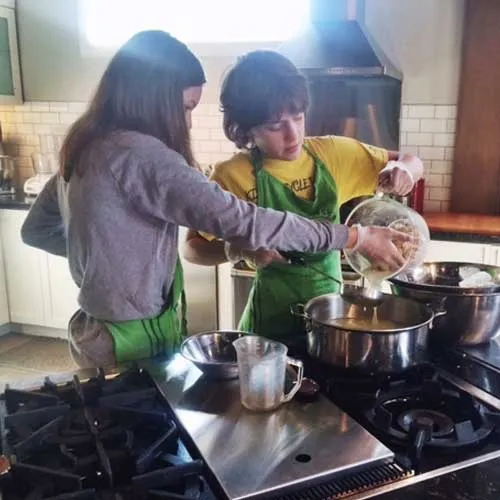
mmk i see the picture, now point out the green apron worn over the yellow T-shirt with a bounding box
[239,146,342,340]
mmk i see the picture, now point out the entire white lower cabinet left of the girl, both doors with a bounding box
[0,210,78,329]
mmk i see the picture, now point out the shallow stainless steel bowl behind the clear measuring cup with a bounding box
[180,330,248,379]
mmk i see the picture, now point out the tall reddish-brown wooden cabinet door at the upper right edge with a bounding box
[451,0,500,214]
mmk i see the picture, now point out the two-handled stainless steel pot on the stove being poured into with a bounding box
[292,286,444,373]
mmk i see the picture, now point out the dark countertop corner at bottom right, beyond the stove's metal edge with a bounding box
[374,459,500,500]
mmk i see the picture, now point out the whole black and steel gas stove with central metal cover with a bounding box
[4,350,500,500]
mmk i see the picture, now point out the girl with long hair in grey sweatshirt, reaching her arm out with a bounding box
[22,31,392,366]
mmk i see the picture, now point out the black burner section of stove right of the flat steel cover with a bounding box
[302,364,500,474]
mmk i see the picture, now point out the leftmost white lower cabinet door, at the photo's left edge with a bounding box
[0,210,47,325]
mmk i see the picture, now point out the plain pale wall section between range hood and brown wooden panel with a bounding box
[365,0,465,104]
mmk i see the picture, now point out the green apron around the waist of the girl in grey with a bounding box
[105,259,187,363]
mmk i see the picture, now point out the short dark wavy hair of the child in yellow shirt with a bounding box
[220,50,309,149]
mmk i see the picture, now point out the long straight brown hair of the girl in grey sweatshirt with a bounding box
[60,31,206,181]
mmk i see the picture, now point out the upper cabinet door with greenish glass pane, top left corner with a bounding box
[0,7,22,104]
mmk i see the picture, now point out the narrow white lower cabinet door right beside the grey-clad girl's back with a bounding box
[44,254,78,329]
